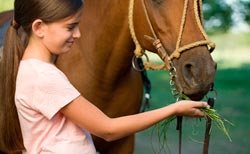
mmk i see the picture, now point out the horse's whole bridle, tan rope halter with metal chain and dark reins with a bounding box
[128,0,215,154]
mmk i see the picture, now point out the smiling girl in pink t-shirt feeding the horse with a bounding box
[0,0,208,154]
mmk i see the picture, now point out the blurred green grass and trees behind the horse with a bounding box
[0,0,250,154]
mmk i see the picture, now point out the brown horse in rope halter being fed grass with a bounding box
[0,0,216,154]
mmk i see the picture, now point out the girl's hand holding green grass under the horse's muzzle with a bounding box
[174,100,209,117]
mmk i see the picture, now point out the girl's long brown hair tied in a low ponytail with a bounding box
[0,0,83,153]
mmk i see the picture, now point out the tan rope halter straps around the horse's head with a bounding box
[128,0,215,71]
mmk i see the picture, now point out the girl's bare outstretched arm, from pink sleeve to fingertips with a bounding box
[60,96,208,141]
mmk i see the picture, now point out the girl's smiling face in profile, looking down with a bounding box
[42,11,81,55]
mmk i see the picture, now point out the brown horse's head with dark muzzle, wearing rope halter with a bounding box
[132,0,216,100]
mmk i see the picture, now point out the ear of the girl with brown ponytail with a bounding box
[32,19,45,38]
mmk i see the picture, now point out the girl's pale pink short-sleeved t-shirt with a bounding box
[15,59,96,154]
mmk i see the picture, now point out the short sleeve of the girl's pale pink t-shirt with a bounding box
[32,69,80,119]
